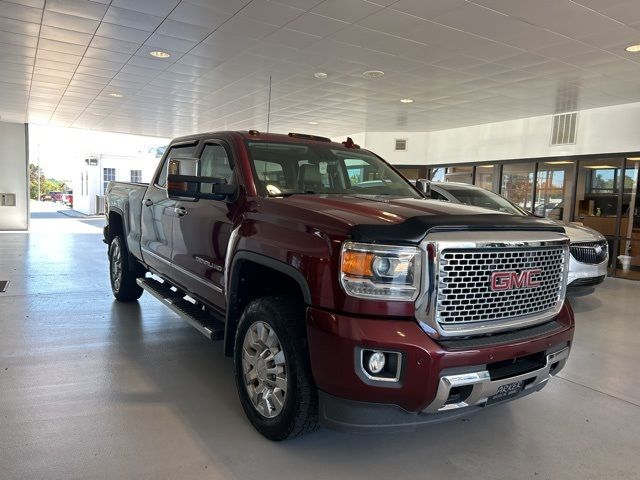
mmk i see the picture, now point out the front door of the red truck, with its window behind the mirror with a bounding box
[172,140,236,309]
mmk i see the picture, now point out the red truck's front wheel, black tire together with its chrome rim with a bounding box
[234,296,318,440]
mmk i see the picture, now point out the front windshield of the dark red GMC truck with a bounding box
[247,142,422,198]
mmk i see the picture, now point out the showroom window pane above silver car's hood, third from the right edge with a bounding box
[534,160,575,222]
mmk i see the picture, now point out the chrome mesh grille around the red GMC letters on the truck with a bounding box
[435,245,566,330]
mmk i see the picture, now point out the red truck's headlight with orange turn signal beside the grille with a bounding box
[340,242,421,301]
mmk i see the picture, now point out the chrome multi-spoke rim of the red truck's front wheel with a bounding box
[242,322,287,418]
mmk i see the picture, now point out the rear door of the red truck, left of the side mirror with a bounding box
[140,142,197,275]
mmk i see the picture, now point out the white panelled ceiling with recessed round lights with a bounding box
[0,0,640,137]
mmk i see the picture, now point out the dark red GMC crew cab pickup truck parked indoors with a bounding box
[104,130,574,440]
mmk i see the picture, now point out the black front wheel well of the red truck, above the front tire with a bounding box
[224,251,311,356]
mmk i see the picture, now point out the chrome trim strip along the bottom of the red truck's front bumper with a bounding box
[423,347,569,413]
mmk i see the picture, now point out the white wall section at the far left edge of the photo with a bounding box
[0,122,29,231]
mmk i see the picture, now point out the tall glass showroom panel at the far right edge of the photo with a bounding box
[615,157,640,280]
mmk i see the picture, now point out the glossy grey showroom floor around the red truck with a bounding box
[0,206,640,480]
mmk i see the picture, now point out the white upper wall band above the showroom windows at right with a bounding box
[353,103,640,165]
